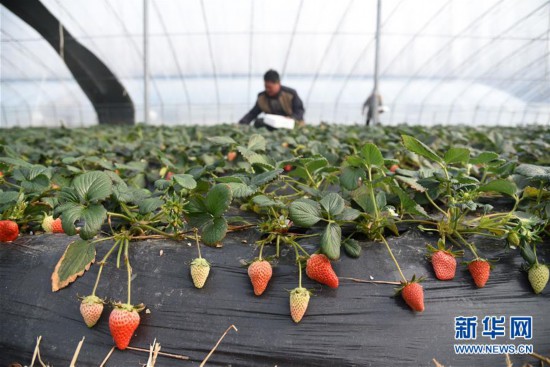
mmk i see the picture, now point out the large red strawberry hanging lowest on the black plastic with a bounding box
[109,303,140,350]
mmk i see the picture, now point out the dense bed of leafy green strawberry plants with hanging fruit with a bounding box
[0,124,550,336]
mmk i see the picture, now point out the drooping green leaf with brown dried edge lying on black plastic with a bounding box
[52,239,95,292]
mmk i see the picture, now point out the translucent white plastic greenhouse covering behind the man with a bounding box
[0,0,550,127]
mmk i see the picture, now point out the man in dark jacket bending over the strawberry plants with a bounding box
[239,70,305,127]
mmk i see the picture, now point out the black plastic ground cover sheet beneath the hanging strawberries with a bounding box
[0,229,550,367]
